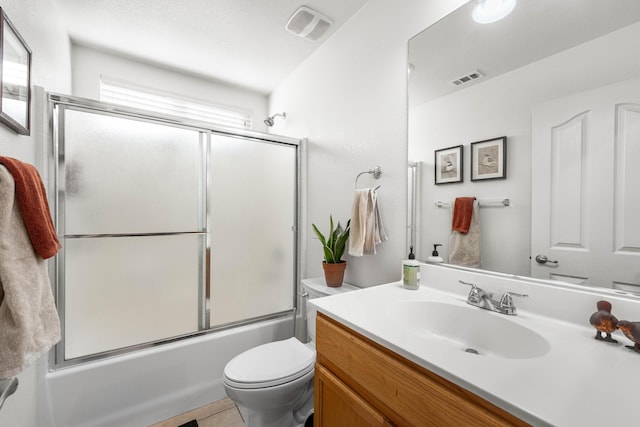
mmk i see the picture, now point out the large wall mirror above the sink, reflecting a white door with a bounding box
[408,0,640,293]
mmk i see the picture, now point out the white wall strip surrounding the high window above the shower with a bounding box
[72,44,267,132]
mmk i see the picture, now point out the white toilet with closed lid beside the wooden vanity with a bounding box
[222,278,359,427]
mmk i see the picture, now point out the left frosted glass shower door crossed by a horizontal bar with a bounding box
[58,108,206,360]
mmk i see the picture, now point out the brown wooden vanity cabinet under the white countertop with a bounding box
[314,312,528,427]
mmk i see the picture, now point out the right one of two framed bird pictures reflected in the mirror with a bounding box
[471,136,507,181]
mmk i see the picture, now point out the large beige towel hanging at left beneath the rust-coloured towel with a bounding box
[0,165,60,379]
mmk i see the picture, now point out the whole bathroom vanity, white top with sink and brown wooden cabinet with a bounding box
[311,265,640,427]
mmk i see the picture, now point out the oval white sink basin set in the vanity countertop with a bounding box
[386,301,550,359]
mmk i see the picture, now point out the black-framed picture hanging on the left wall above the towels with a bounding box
[0,8,31,135]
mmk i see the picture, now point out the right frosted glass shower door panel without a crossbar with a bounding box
[209,136,297,327]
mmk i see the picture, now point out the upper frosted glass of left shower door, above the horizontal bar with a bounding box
[64,110,204,235]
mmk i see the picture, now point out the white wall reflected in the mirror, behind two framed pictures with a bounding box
[409,20,640,275]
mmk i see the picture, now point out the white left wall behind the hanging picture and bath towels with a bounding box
[0,0,71,427]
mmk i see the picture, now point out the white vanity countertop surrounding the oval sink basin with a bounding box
[310,282,640,427]
